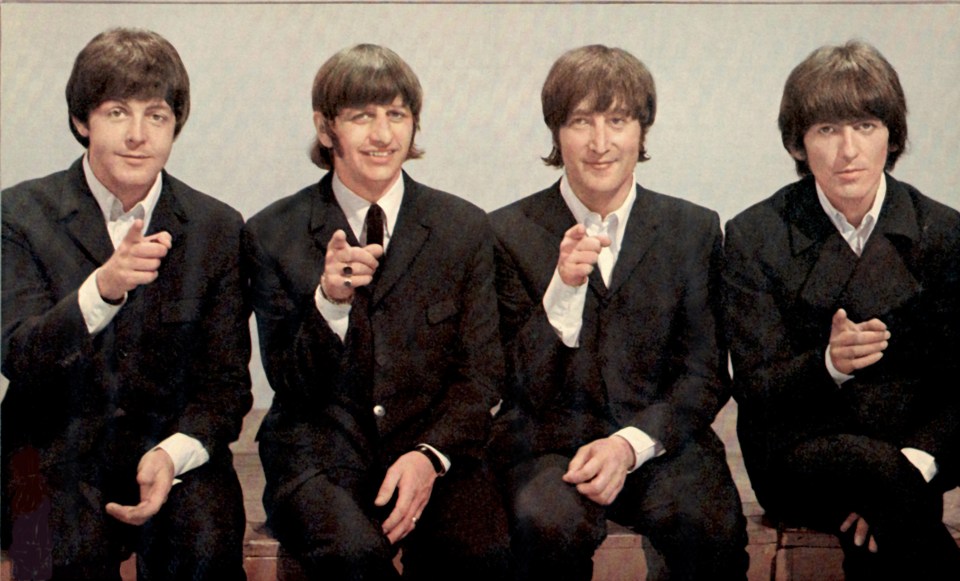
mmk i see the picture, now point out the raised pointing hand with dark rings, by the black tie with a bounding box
[320,230,383,303]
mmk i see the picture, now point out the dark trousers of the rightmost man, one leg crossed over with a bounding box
[762,434,960,579]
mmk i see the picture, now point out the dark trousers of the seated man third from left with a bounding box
[507,432,749,580]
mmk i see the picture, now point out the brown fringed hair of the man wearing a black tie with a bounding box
[310,44,423,169]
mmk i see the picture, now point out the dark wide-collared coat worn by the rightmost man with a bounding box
[724,175,960,501]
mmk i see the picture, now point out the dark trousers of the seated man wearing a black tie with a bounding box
[261,454,509,580]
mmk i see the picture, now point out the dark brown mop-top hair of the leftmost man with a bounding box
[66,28,190,147]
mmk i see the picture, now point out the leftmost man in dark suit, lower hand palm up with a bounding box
[0,29,252,579]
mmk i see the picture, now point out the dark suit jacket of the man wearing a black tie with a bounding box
[245,174,503,500]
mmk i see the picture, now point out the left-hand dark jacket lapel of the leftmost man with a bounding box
[58,159,113,265]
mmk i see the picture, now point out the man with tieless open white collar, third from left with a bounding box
[491,45,747,579]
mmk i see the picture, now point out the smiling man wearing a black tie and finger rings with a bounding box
[245,45,509,579]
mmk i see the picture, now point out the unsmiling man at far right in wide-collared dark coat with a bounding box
[724,42,960,579]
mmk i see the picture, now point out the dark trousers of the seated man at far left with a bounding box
[27,458,246,581]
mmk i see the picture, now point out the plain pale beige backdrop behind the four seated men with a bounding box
[0,2,960,407]
